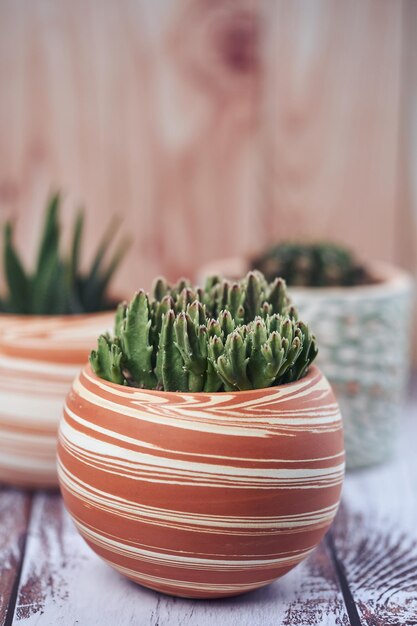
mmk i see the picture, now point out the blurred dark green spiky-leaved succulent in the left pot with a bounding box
[0,193,126,315]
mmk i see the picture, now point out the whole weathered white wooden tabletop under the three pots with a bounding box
[0,377,417,626]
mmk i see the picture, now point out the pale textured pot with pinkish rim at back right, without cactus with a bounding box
[199,257,413,469]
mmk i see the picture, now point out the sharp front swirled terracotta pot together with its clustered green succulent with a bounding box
[58,272,344,598]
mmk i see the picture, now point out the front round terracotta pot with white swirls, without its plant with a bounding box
[58,366,344,598]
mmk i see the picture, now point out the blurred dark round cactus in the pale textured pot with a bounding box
[251,242,369,287]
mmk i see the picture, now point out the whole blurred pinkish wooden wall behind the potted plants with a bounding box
[0,0,417,304]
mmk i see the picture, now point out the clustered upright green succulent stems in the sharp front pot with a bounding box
[90,272,317,392]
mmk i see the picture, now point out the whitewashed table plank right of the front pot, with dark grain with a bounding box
[332,381,417,626]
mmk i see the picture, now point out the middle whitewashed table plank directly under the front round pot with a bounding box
[9,494,349,626]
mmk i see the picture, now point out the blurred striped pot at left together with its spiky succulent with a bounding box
[0,194,124,487]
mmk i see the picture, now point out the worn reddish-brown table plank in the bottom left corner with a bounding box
[0,487,31,626]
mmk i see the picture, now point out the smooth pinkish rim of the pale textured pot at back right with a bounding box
[200,256,414,298]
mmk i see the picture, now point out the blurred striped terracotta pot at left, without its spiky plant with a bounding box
[0,313,114,488]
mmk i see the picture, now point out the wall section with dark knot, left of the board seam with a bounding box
[0,0,259,290]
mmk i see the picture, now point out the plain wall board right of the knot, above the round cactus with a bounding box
[265,1,403,259]
